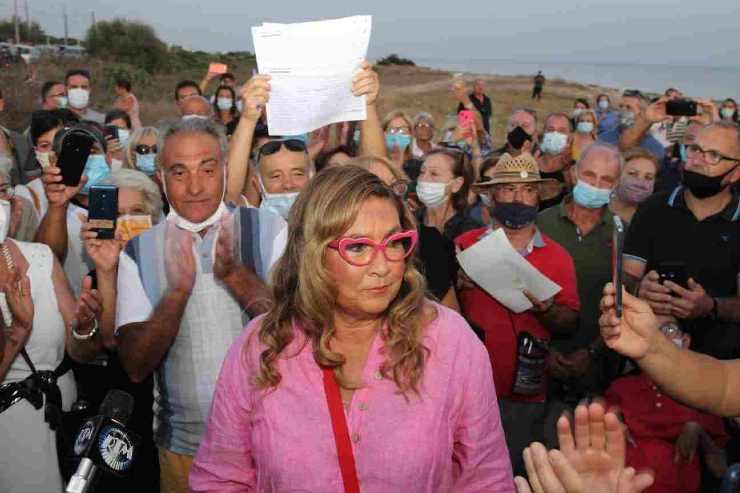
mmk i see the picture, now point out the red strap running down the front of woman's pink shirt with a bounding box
[321,368,360,493]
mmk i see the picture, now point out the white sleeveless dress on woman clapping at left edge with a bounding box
[0,242,77,493]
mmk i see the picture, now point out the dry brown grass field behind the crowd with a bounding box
[0,59,616,143]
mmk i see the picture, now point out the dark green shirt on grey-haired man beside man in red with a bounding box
[537,195,614,353]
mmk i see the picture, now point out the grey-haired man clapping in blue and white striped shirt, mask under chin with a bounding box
[116,118,287,492]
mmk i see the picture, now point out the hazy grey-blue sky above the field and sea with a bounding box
[0,0,740,66]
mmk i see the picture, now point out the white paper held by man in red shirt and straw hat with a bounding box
[457,228,562,313]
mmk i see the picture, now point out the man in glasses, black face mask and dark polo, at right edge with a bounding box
[624,122,740,358]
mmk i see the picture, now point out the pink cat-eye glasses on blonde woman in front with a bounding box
[329,229,419,267]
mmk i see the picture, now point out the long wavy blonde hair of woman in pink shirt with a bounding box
[252,165,429,395]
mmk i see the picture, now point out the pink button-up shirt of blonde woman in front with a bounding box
[190,305,514,493]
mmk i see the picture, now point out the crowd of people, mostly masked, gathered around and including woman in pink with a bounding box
[0,57,740,493]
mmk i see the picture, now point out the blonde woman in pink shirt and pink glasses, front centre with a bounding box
[190,166,514,493]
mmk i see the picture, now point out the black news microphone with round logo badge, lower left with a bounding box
[64,389,139,493]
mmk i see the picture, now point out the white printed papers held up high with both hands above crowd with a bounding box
[252,16,372,135]
